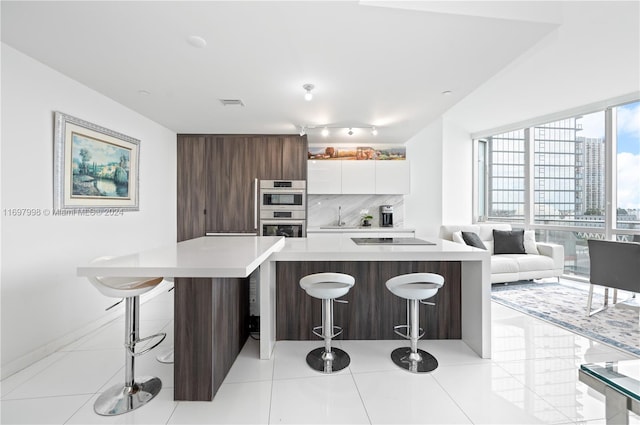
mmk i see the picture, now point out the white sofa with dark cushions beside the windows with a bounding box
[440,223,564,283]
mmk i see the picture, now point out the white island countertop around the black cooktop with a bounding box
[271,234,490,261]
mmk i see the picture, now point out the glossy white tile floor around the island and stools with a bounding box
[0,286,640,425]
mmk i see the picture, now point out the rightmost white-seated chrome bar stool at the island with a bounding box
[385,273,444,373]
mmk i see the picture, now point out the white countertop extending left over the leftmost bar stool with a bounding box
[77,236,285,277]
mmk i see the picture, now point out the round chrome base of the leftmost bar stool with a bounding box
[93,376,162,416]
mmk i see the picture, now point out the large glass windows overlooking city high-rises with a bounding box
[476,101,640,277]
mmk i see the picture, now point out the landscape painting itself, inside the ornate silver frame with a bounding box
[71,132,131,198]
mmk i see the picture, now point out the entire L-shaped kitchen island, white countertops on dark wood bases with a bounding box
[77,235,491,401]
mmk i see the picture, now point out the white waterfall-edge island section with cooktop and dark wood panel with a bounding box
[260,235,491,359]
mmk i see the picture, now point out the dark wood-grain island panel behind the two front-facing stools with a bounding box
[276,261,462,340]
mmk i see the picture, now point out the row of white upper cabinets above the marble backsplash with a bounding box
[307,160,411,195]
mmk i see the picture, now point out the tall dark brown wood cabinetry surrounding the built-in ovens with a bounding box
[177,135,308,241]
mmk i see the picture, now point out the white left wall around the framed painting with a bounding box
[1,44,176,377]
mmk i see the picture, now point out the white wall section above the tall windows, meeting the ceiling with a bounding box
[445,1,640,133]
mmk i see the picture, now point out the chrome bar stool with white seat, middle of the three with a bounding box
[300,273,355,373]
